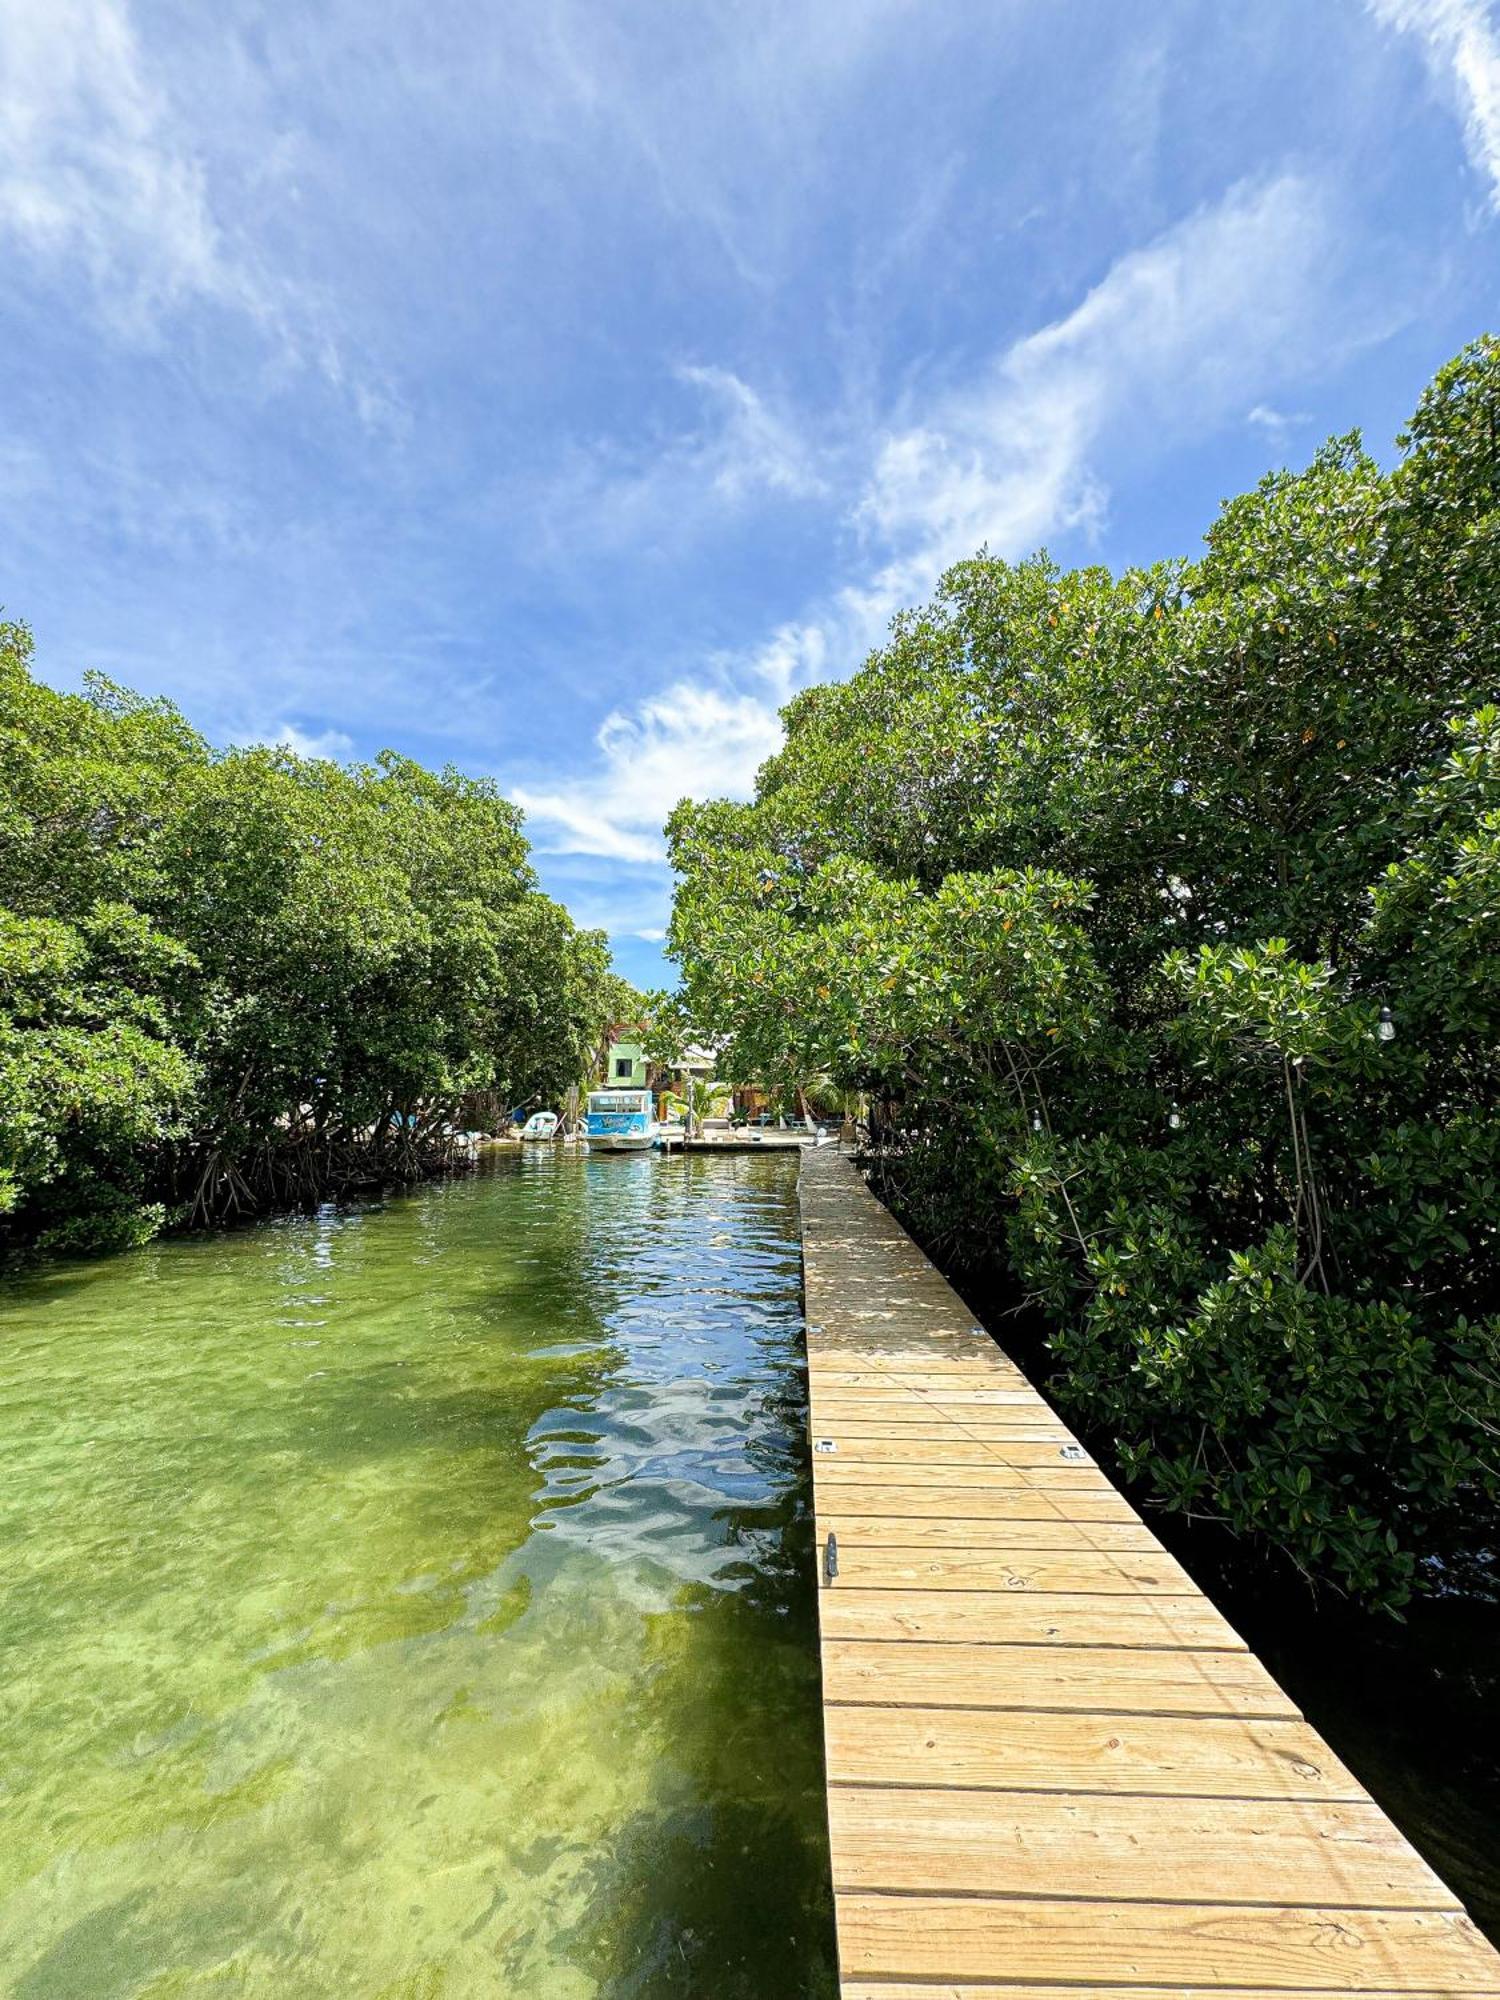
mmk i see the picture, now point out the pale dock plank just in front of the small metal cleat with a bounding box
[822,1584,1244,1652]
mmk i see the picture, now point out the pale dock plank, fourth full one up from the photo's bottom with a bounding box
[822,1638,1298,1718]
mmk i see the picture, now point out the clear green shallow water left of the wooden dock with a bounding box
[0,1152,834,2000]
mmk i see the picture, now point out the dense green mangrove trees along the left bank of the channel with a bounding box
[0,626,614,1248]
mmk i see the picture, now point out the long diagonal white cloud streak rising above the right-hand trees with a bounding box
[516,176,1338,864]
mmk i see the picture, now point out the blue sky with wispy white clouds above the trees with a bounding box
[0,0,1500,982]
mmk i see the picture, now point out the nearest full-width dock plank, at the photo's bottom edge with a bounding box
[838,1894,1496,2000]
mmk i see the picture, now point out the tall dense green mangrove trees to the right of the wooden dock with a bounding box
[670,340,1500,1604]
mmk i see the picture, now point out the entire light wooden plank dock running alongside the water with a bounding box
[802,1148,1500,2000]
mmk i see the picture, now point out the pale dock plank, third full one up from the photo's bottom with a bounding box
[824,1702,1364,1800]
